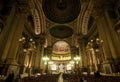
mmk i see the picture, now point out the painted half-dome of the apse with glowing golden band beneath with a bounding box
[52,41,71,61]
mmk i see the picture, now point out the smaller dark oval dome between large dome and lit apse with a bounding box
[49,25,73,39]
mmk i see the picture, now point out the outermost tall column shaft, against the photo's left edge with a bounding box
[0,4,17,62]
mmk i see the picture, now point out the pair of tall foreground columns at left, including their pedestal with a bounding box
[0,5,27,73]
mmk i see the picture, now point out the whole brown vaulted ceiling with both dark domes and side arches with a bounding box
[15,0,114,60]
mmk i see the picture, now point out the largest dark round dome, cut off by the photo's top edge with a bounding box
[42,0,80,23]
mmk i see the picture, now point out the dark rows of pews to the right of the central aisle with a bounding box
[62,74,120,82]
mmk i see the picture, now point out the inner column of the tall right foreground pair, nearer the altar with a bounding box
[97,17,113,72]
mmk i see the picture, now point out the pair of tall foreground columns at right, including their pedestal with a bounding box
[97,11,119,73]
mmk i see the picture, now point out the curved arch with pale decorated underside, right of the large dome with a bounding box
[77,0,93,35]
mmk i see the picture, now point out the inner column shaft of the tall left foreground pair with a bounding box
[7,14,26,63]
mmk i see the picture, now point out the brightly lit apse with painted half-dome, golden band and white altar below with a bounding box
[51,41,71,72]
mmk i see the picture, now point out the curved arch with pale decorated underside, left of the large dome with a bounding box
[32,1,46,35]
